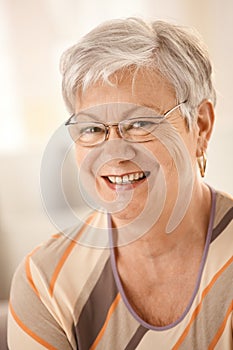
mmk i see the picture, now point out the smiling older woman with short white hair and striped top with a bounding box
[9,18,233,350]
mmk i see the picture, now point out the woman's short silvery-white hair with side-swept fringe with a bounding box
[60,18,216,126]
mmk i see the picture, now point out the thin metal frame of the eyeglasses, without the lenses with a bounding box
[65,100,187,147]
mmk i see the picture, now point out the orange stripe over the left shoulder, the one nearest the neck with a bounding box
[49,214,94,296]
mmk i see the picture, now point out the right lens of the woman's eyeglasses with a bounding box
[119,117,163,142]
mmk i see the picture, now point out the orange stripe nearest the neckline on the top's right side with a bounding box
[172,257,233,350]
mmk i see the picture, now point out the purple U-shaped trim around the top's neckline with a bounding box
[108,187,216,331]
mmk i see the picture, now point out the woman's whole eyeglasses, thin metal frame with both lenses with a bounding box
[65,101,187,147]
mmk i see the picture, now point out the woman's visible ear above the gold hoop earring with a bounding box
[197,100,215,157]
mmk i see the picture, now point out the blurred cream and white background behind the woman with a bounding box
[0,0,233,299]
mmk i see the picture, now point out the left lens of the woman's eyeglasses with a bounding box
[69,122,105,146]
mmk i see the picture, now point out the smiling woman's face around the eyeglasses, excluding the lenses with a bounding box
[75,71,197,231]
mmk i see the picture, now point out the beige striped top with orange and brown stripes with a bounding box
[8,192,233,350]
